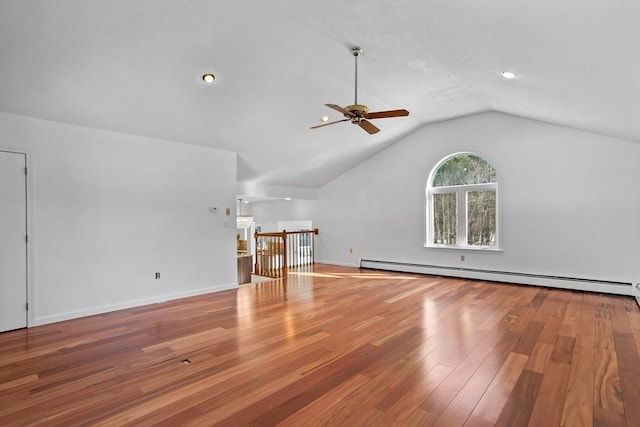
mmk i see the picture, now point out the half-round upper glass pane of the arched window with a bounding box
[432,154,496,187]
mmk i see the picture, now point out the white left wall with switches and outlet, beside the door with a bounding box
[0,113,237,325]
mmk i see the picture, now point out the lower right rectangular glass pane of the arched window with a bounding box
[467,190,496,246]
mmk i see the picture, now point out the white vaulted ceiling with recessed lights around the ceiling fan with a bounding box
[0,0,640,194]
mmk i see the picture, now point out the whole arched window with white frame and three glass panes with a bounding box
[427,153,500,249]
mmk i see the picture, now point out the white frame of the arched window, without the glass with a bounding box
[425,151,502,252]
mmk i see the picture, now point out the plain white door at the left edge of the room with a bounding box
[0,151,27,332]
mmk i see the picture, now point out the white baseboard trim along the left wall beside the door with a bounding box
[29,283,238,327]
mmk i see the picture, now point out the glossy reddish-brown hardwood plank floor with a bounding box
[0,265,640,427]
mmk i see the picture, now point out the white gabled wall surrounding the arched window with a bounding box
[309,113,640,292]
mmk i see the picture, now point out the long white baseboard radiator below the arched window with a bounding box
[360,259,640,304]
